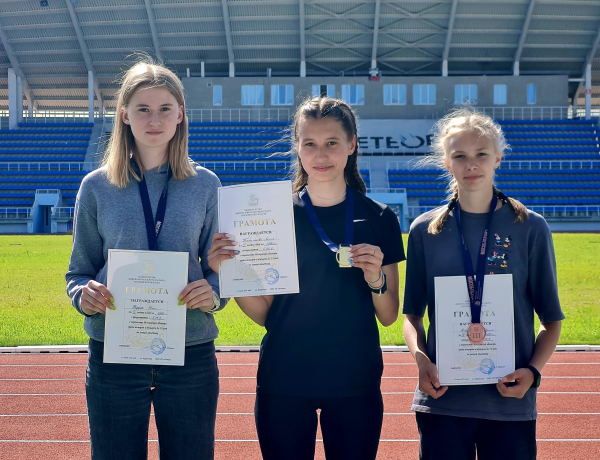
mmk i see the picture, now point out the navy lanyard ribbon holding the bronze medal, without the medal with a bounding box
[454,195,498,323]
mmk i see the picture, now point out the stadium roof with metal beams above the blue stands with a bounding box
[0,0,600,109]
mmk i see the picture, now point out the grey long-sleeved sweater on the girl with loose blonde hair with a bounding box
[66,166,225,345]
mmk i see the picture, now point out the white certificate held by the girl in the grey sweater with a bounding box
[104,249,189,366]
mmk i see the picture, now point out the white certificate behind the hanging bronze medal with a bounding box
[435,275,515,385]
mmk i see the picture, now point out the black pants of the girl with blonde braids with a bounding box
[417,412,537,460]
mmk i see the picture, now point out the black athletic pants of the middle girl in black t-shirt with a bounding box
[254,392,382,460]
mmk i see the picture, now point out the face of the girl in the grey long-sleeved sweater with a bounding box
[121,87,183,155]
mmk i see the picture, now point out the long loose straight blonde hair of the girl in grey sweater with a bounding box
[102,59,196,188]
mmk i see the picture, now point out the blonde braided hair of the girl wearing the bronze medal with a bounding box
[423,107,529,235]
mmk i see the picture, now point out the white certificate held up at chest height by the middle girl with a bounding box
[219,181,300,297]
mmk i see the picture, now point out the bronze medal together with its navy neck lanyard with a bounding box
[454,195,498,345]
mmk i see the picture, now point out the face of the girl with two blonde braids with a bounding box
[444,130,502,192]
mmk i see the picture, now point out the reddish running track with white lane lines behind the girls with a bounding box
[0,352,600,460]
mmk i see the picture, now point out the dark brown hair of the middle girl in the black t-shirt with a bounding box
[291,97,367,195]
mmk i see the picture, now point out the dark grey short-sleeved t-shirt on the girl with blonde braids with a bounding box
[402,204,564,420]
